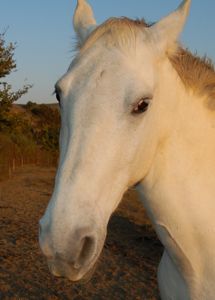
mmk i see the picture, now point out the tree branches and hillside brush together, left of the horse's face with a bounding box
[0,34,60,179]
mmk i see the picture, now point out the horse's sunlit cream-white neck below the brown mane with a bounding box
[139,58,215,288]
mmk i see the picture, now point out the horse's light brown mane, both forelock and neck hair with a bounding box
[80,17,215,99]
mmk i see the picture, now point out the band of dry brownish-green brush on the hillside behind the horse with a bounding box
[0,103,60,179]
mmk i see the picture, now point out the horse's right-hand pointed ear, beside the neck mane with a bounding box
[149,0,191,51]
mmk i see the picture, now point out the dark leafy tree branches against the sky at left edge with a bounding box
[0,33,31,115]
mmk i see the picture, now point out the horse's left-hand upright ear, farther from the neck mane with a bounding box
[73,0,96,45]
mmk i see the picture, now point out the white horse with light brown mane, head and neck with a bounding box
[40,0,215,300]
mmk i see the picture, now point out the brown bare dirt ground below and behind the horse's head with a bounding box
[0,167,162,300]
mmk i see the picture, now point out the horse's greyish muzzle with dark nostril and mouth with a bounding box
[39,222,106,281]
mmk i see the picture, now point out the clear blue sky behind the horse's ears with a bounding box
[0,0,215,103]
